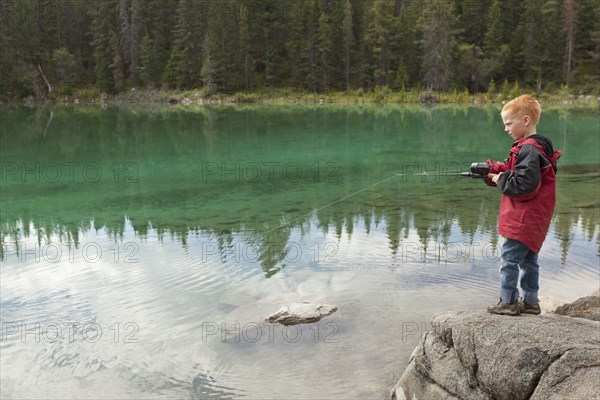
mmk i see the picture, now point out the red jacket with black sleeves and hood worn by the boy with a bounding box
[486,135,562,253]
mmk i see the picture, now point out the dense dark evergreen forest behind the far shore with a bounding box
[0,0,600,99]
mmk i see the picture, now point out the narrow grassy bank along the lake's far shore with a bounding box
[5,86,600,108]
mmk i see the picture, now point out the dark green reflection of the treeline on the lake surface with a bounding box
[0,107,600,277]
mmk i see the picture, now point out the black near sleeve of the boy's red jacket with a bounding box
[497,144,542,201]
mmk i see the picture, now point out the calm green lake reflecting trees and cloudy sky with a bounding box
[0,105,600,399]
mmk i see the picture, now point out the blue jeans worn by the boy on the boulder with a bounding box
[500,238,540,304]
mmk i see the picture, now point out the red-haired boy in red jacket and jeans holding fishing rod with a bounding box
[486,96,562,315]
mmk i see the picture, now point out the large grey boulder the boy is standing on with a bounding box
[392,311,600,400]
